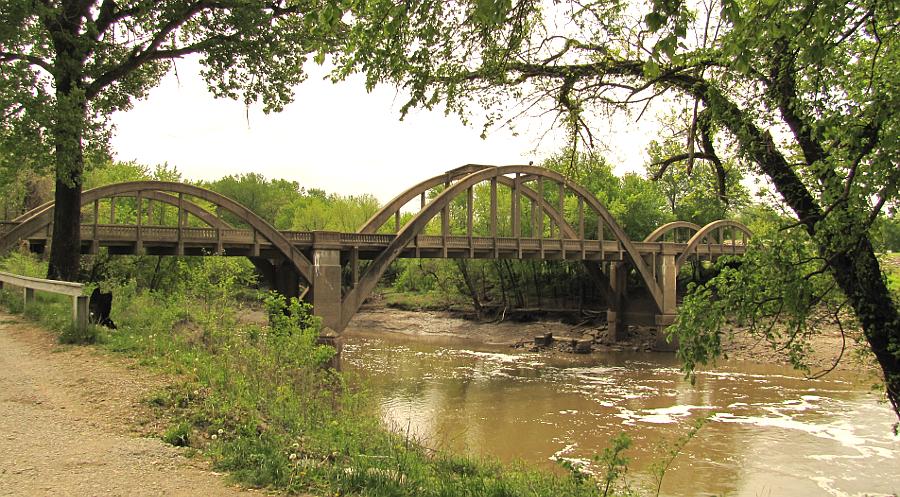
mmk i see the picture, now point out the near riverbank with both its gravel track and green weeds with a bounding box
[0,280,612,497]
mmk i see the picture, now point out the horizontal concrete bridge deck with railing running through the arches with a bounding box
[3,222,744,261]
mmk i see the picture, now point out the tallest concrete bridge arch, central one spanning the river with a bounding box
[341,165,663,328]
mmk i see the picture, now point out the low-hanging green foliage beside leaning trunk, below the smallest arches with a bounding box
[667,231,845,373]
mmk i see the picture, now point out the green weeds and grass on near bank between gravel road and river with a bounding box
[2,254,652,496]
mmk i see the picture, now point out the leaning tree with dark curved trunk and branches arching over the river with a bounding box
[339,0,900,415]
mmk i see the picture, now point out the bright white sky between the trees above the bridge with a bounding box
[112,59,654,202]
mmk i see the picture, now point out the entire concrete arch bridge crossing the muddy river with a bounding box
[0,165,751,342]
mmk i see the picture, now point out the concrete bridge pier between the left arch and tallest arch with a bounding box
[310,231,341,331]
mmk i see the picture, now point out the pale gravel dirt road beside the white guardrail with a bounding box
[0,312,261,496]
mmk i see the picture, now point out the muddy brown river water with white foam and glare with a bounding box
[344,336,900,496]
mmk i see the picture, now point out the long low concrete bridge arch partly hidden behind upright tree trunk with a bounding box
[0,181,312,281]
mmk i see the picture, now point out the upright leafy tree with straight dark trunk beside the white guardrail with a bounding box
[0,0,342,279]
